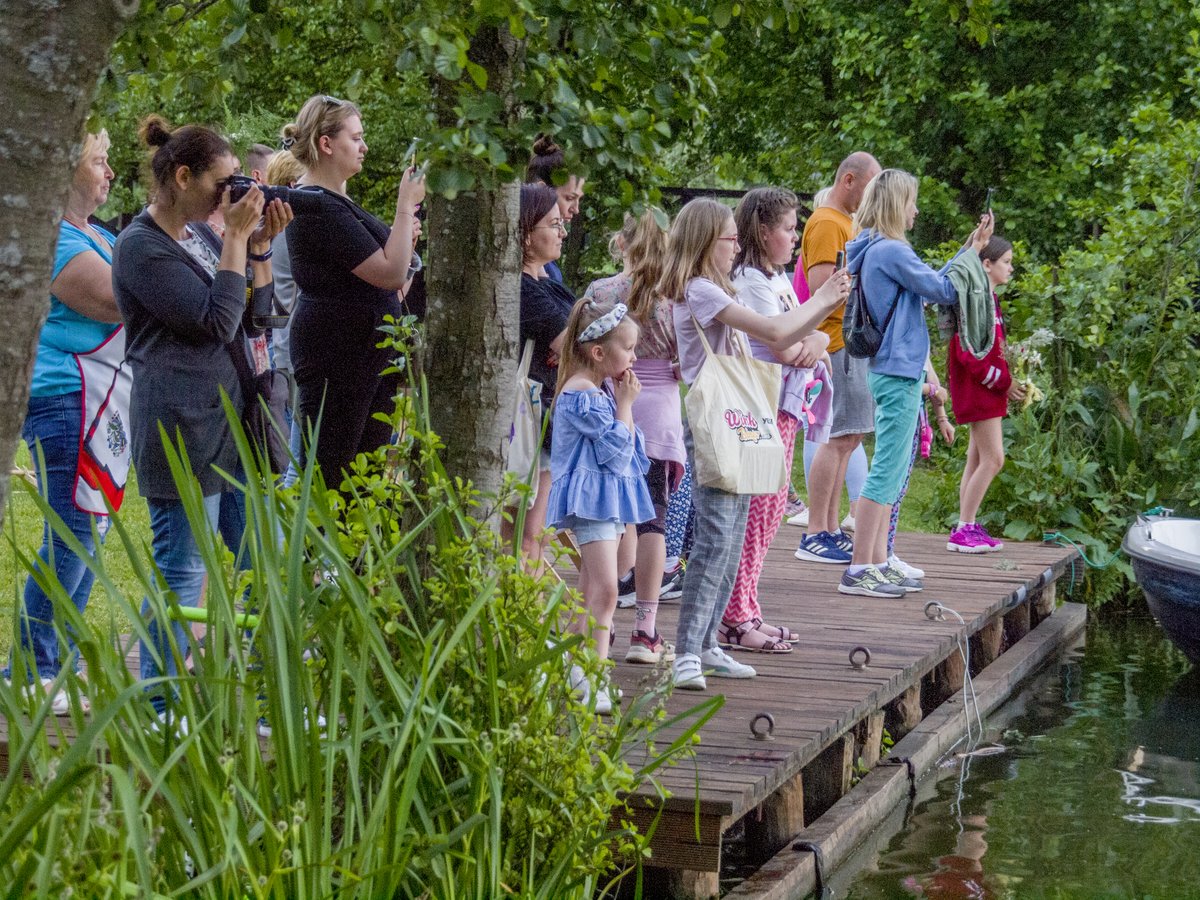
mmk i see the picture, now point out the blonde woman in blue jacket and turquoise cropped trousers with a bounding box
[838,169,994,598]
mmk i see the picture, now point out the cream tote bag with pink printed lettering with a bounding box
[684,316,787,494]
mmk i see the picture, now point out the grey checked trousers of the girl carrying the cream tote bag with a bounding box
[676,426,750,656]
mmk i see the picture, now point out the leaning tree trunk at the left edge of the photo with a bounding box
[0,0,138,535]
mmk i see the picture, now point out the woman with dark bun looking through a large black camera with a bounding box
[113,116,292,712]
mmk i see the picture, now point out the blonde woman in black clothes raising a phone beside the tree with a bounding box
[283,96,425,486]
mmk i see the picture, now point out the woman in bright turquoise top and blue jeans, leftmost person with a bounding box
[6,131,132,714]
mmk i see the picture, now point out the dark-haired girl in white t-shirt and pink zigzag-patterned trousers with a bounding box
[716,187,829,653]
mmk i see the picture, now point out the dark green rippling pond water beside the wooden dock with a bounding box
[830,613,1200,900]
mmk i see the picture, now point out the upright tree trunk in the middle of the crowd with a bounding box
[424,29,523,508]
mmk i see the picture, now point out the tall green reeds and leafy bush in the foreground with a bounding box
[0,355,720,899]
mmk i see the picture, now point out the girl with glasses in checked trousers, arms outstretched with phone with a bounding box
[659,198,850,690]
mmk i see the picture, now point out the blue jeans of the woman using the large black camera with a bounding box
[140,493,241,712]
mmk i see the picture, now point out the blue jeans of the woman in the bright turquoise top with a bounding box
[5,391,108,678]
